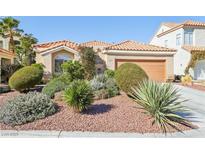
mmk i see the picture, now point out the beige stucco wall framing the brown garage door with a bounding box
[105,51,174,79]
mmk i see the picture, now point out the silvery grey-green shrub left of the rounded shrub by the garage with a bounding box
[90,74,119,99]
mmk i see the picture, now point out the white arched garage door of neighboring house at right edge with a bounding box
[194,60,205,80]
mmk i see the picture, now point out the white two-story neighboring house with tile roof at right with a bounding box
[150,21,205,80]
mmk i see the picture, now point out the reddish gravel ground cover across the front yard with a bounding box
[0,93,195,133]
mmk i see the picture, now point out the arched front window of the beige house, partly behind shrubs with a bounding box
[55,54,71,73]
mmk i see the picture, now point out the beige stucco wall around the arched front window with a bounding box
[36,49,78,73]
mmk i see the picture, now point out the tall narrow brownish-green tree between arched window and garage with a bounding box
[81,47,96,80]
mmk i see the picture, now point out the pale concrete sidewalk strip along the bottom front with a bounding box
[0,128,205,138]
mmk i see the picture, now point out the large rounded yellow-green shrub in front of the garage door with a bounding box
[115,63,148,93]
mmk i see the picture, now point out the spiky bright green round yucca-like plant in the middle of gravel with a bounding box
[63,80,93,112]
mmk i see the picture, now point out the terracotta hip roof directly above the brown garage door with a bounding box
[106,40,176,52]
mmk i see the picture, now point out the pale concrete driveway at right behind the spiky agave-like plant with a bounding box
[175,85,205,128]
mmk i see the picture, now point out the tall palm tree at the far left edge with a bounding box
[0,17,23,52]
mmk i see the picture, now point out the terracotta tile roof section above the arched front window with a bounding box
[34,40,79,52]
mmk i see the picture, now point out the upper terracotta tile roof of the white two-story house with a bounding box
[157,20,205,37]
